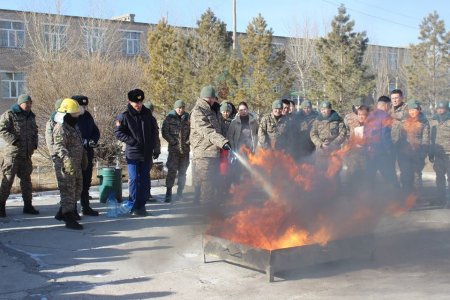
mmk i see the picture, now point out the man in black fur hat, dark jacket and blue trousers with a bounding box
[114,89,161,216]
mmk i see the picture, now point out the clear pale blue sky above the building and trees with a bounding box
[0,0,450,47]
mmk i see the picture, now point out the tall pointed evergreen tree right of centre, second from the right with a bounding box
[313,5,374,110]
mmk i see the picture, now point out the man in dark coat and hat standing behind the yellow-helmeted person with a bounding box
[71,95,100,216]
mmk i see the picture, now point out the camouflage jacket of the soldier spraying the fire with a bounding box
[189,99,228,158]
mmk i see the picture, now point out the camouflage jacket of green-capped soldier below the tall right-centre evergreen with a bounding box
[310,110,347,149]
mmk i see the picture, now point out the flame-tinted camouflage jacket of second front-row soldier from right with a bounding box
[398,113,430,155]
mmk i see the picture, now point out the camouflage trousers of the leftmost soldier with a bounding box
[0,156,33,205]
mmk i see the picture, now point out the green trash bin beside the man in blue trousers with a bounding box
[97,167,122,203]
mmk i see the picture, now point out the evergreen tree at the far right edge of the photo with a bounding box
[407,11,450,106]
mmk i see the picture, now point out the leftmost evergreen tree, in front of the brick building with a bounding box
[141,19,186,112]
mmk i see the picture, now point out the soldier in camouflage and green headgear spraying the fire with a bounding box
[189,86,228,202]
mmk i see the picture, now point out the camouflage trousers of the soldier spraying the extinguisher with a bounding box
[192,157,221,203]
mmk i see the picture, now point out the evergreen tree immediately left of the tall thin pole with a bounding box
[185,8,231,99]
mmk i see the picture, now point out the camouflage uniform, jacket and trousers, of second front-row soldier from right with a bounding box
[397,112,430,192]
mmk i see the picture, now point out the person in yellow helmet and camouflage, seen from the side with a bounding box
[52,98,87,230]
